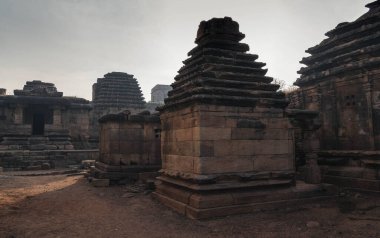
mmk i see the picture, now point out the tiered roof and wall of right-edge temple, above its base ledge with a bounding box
[290,1,380,150]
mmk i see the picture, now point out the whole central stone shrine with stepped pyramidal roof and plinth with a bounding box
[155,17,332,218]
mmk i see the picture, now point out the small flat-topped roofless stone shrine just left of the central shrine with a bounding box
[94,111,161,180]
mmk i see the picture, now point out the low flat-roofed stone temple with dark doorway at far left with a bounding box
[0,81,91,168]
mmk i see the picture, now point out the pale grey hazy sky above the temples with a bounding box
[0,0,374,101]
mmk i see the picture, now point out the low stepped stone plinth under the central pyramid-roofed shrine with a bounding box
[153,176,336,219]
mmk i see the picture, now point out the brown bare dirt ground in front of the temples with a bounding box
[0,173,380,238]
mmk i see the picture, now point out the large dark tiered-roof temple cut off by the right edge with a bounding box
[289,1,380,190]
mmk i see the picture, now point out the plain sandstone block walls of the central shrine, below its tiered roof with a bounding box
[161,105,294,179]
